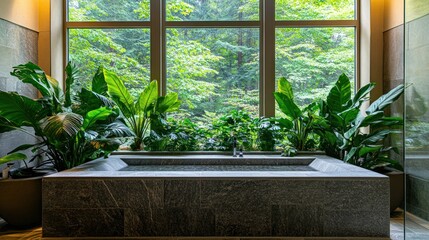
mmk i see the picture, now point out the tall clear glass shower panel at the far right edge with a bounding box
[402,0,429,239]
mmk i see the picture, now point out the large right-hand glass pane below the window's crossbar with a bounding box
[276,28,355,112]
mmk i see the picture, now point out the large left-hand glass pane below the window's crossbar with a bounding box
[69,29,150,94]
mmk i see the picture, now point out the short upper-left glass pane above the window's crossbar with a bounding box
[67,0,150,21]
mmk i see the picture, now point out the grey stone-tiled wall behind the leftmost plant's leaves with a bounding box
[0,17,38,161]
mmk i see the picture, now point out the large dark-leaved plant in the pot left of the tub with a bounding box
[0,63,128,171]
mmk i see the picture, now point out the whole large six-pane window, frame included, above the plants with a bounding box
[65,0,359,121]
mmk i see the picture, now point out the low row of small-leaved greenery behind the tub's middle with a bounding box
[144,110,280,151]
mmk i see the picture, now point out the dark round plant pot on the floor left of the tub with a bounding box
[0,176,42,228]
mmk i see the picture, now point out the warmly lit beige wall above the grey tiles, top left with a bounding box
[0,0,39,31]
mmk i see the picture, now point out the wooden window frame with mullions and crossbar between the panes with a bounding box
[63,0,361,117]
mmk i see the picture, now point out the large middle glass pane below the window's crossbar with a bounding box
[167,28,259,122]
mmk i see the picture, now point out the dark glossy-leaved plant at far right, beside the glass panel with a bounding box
[317,74,404,169]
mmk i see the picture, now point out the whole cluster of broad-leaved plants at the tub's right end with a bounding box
[275,74,404,169]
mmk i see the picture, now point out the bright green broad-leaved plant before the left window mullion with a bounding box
[100,68,180,150]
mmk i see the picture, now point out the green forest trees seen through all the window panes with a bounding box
[69,0,355,123]
